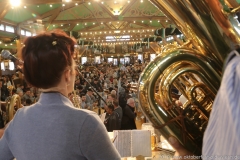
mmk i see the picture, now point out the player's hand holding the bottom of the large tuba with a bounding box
[168,137,196,160]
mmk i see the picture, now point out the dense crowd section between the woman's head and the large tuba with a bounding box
[65,61,147,132]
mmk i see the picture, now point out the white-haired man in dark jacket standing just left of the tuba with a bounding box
[121,98,137,130]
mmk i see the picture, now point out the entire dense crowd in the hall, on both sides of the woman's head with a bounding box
[0,49,146,131]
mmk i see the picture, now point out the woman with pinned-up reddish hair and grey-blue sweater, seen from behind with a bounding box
[0,30,121,160]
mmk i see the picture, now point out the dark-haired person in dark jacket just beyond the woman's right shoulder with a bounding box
[104,104,120,132]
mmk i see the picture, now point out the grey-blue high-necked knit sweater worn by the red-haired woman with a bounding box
[0,93,121,160]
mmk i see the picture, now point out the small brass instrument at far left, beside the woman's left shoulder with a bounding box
[3,94,22,125]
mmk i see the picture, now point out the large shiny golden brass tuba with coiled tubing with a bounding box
[138,0,240,155]
